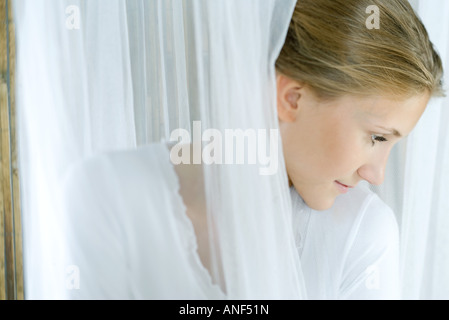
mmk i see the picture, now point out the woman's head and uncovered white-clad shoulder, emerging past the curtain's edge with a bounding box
[276,0,442,299]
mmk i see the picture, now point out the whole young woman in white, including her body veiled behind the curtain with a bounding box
[64,0,442,299]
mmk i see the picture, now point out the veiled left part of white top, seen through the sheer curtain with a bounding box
[63,144,224,300]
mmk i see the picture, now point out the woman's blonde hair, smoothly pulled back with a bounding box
[276,0,444,98]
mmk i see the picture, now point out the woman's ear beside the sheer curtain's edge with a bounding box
[276,74,302,122]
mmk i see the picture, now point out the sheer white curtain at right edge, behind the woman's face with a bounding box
[375,0,449,299]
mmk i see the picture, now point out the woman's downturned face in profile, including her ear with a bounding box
[277,75,430,210]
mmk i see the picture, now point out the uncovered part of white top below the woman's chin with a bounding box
[290,186,400,300]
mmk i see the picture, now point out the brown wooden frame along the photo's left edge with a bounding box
[0,0,24,300]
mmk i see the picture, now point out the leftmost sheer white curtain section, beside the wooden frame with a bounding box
[14,0,137,299]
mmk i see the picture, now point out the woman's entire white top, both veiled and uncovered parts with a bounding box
[62,144,398,299]
